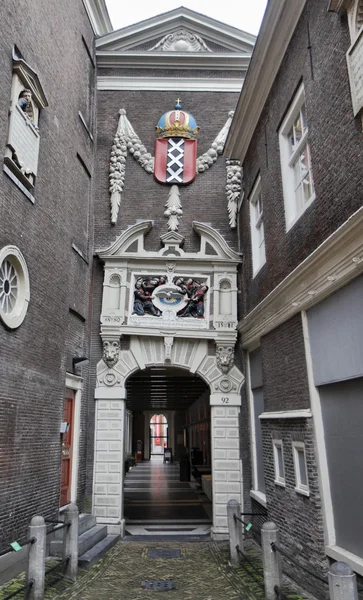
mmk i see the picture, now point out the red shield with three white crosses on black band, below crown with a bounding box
[154,137,197,185]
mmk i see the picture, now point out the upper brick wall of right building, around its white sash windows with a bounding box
[240,0,362,314]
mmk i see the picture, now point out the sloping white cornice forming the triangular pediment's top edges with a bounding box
[96,7,256,51]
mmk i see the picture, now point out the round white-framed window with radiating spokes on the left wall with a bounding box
[0,246,29,329]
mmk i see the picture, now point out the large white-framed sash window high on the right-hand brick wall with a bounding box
[279,85,315,231]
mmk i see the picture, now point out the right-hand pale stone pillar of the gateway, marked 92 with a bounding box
[210,394,242,539]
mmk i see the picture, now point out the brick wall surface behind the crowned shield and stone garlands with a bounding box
[95,89,238,251]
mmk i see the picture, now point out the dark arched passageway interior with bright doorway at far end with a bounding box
[124,367,213,536]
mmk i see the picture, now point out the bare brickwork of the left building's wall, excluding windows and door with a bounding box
[0,0,94,545]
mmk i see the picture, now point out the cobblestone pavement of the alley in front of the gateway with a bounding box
[0,541,307,600]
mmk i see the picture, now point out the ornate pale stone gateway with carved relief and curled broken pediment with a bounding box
[93,221,244,535]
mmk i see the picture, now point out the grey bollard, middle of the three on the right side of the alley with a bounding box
[261,521,282,600]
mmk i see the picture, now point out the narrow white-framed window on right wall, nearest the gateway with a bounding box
[249,175,266,277]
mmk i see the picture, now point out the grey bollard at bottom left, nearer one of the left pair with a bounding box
[27,516,47,600]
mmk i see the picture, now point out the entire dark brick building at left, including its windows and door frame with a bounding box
[0,0,111,571]
